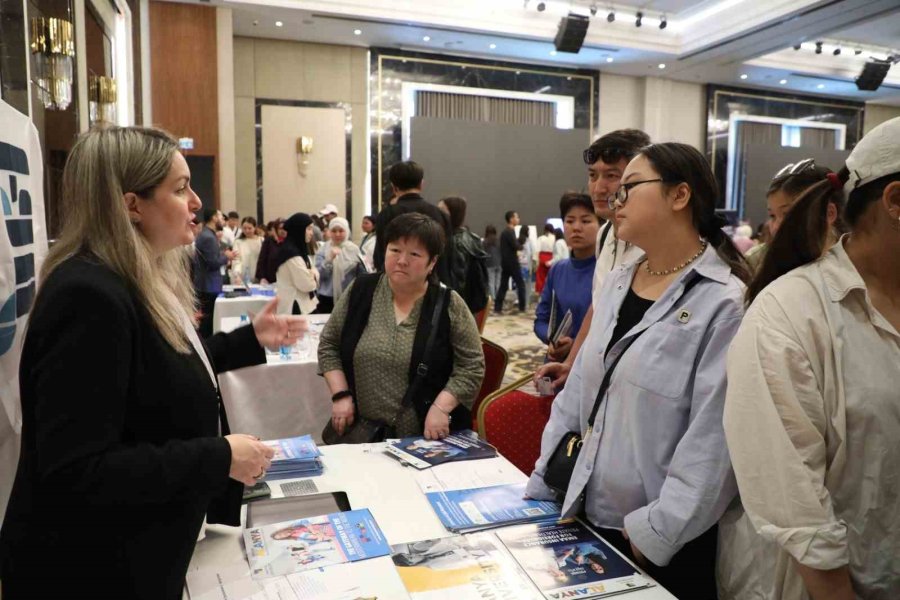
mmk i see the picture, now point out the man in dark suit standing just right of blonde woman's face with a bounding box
[193,208,236,337]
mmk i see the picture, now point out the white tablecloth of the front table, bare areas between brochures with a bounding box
[190,444,675,600]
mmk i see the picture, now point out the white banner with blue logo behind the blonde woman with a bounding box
[0,100,47,436]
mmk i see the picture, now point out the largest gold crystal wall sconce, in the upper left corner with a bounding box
[31,17,75,110]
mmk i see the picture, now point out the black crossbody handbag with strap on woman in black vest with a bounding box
[322,288,450,446]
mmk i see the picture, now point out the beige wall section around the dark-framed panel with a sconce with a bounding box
[233,37,370,239]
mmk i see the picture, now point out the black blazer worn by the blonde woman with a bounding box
[0,256,265,600]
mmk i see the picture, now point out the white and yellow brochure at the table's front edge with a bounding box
[391,533,541,600]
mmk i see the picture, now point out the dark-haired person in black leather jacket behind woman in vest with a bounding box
[438,196,491,315]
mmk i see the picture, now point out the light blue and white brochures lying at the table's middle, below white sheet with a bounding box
[425,483,561,533]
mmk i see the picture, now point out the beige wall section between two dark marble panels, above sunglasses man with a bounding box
[599,73,706,150]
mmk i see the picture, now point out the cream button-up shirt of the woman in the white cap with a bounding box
[720,238,900,600]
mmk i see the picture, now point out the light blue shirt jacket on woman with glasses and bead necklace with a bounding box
[526,241,744,566]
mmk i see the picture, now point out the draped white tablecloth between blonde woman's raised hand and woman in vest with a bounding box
[216,314,331,442]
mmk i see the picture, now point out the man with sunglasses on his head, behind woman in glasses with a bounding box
[535,129,650,389]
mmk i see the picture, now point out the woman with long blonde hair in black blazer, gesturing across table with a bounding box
[0,127,307,600]
